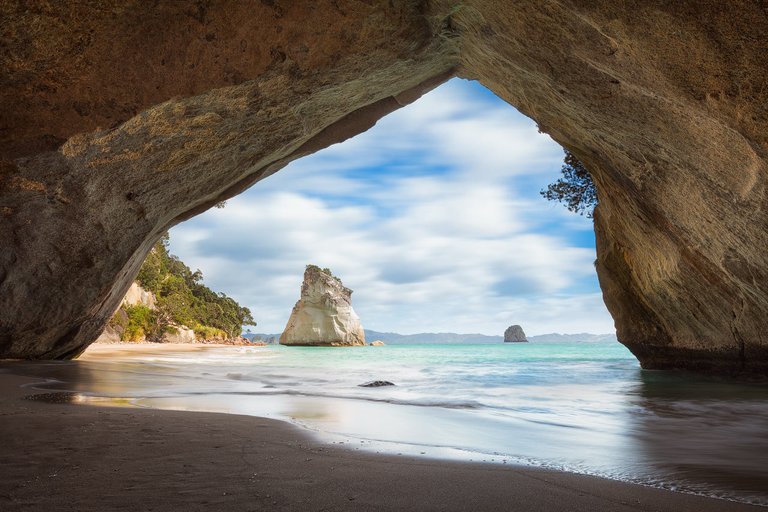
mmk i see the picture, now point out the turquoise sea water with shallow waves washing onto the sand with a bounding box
[0,342,768,505]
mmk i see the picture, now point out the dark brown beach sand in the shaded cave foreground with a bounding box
[0,374,765,512]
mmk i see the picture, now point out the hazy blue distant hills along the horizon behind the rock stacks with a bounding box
[243,329,617,345]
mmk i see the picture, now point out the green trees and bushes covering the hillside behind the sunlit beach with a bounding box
[112,235,256,341]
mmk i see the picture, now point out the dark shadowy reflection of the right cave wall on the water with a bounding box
[627,372,768,503]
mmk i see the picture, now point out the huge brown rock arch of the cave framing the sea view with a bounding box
[0,0,768,373]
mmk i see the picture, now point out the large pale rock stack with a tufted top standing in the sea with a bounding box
[280,265,365,346]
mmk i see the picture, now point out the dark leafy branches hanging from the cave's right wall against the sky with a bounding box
[541,150,597,219]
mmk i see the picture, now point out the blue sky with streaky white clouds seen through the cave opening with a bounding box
[170,78,614,335]
